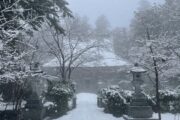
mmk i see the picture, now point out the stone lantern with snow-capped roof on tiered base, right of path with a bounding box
[124,64,157,120]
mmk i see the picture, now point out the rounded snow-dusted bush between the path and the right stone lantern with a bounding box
[98,86,155,116]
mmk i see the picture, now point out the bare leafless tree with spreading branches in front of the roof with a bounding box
[42,17,95,82]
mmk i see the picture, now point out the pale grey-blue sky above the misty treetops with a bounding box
[67,0,164,27]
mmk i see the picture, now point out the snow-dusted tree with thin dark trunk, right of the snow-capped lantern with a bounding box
[131,0,180,119]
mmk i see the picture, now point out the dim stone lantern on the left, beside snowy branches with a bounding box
[23,63,45,120]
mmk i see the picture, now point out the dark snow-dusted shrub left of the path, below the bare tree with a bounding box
[46,82,74,115]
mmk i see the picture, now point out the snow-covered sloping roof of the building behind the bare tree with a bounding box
[43,39,129,67]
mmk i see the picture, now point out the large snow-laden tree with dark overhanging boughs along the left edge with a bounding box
[0,0,71,111]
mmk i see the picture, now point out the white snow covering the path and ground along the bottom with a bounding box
[54,93,180,120]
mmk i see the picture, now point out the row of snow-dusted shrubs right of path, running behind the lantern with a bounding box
[98,86,180,116]
